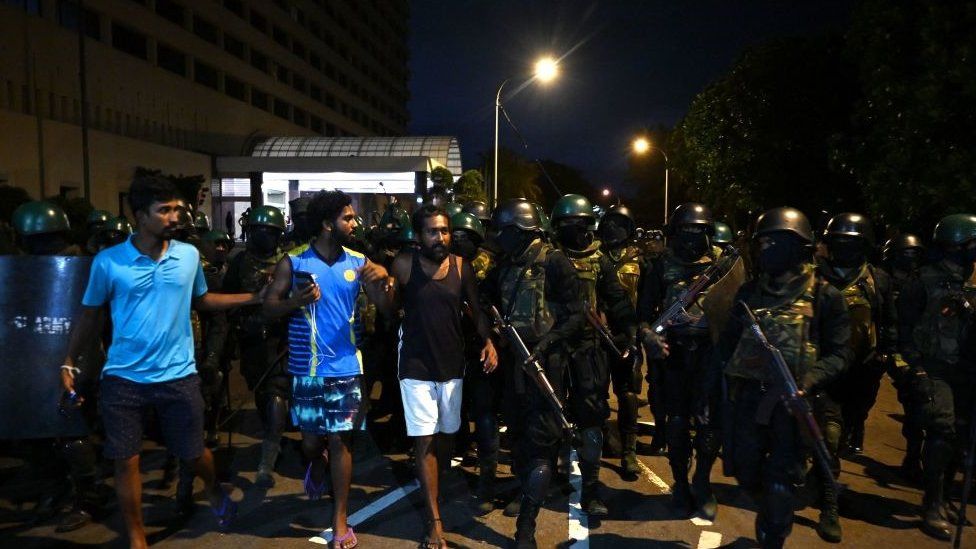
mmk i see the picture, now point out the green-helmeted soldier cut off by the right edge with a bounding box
[896,214,976,540]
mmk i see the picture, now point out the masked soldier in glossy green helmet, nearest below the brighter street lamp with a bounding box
[552,194,637,516]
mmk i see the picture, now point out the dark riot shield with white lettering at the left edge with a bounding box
[0,255,101,439]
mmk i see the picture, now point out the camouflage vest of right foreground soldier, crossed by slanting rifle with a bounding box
[725,266,822,383]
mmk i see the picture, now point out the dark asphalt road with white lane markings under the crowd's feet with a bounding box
[0,366,976,549]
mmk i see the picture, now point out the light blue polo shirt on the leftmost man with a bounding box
[81,236,207,383]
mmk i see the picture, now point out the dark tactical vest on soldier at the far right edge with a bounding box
[912,262,976,364]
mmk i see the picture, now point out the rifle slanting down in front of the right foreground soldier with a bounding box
[739,301,836,489]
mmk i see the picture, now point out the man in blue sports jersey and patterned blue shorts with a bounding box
[264,191,393,549]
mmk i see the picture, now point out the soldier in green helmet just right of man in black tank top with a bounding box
[451,213,502,515]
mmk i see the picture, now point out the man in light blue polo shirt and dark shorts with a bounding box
[61,176,261,548]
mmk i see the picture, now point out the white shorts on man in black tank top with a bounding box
[400,379,462,437]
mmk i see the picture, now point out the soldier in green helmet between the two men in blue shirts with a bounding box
[223,206,291,488]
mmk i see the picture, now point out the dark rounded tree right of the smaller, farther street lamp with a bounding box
[670,36,863,227]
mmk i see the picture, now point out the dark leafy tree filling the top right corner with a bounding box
[834,0,976,234]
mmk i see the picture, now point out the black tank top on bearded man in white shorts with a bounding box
[399,253,464,381]
